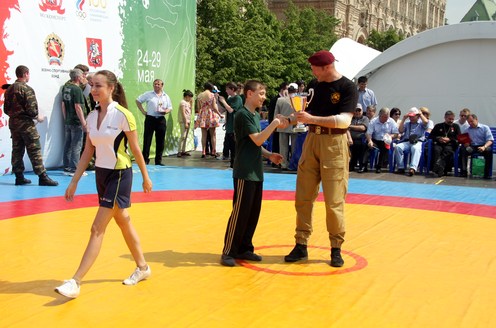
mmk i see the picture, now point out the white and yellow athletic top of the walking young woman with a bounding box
[86,101,136,170]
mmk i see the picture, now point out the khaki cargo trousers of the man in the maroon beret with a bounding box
[295,132,350,247]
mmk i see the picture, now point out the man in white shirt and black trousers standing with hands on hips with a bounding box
[136,79,172,166]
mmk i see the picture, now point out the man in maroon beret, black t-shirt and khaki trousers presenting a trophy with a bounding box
[284,50,358,267]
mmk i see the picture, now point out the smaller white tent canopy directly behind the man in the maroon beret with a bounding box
[331,38,381,80]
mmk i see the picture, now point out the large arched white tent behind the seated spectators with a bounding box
[355,22,496,126]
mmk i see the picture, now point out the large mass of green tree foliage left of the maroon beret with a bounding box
[196,0,338,94]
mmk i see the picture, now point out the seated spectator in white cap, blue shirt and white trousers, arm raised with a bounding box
[394,107,427,176]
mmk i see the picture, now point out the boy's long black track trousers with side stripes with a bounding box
[222,178,263,257]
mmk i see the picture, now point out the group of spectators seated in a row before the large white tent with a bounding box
[349,77,494,179]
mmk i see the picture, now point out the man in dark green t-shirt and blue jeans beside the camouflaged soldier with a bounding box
[61,68,86,175]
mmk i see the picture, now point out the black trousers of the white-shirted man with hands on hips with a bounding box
[142,115,167,164]
